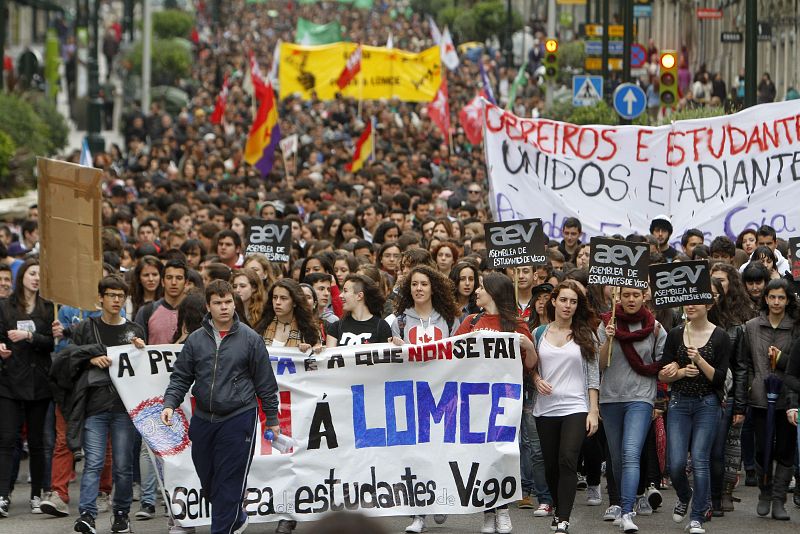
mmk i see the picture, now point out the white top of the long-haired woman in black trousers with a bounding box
[533,337,589,417]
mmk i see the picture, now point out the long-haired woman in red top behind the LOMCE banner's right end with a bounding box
[454,273,540,534]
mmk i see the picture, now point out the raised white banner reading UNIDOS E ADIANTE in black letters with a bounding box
[484,101,800,247]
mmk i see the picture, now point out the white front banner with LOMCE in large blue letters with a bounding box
[108,332,522,526]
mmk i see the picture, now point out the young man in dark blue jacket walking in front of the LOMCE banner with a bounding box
[161,280,280,534]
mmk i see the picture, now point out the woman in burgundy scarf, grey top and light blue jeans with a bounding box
[597,287,667,534]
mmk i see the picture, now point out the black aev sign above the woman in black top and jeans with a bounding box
[650,260,714,310]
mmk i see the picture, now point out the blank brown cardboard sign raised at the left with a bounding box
[36,158,103,310]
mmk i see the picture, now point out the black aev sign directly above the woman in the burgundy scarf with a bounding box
[589,237,650,289]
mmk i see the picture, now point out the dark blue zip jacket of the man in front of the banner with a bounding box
[164,314,278,426]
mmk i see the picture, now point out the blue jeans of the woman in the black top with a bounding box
[667,391,722,523]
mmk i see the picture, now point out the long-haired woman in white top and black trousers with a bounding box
[533,280,600,534]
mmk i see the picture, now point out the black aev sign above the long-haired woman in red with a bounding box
[483,219,547,269]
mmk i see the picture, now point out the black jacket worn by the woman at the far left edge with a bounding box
[0,296,55,402]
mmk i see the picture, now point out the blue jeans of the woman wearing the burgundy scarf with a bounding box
[600,401,653,514]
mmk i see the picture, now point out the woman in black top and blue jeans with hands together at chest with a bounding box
[658,304,730,534]
